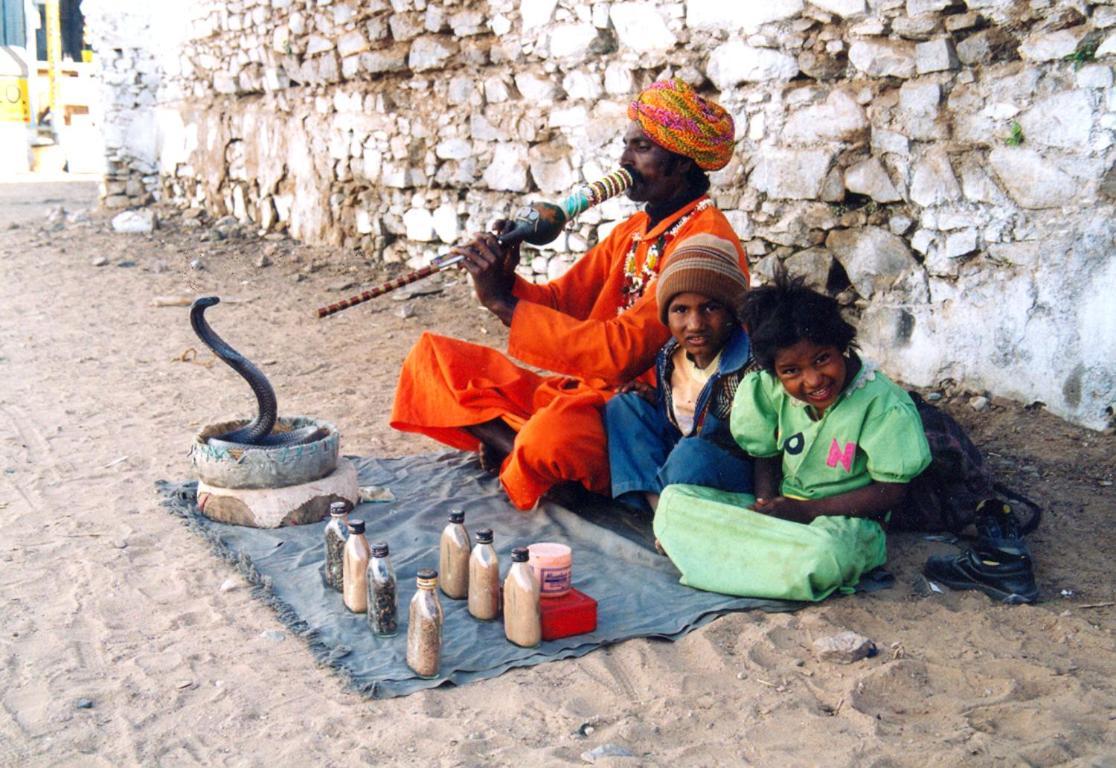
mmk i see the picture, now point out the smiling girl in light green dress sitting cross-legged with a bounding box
[654,273,931,601]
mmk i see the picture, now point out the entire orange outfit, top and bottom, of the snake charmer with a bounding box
[392,198,748,509]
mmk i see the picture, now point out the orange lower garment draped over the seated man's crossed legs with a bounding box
[391,333,610,509]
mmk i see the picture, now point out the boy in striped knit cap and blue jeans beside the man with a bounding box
[605,234,752,509]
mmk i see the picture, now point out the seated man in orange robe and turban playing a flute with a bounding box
[391,81,748,509]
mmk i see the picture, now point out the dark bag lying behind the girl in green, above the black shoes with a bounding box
[889,392,1041,534]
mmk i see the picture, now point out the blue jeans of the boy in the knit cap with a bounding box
[605,392,752,511]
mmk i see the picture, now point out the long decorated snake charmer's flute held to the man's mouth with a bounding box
[318,169,632,318]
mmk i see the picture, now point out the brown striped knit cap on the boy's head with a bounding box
[655,234,748,325]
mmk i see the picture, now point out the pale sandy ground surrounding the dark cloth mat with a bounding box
[0,177,1116,767]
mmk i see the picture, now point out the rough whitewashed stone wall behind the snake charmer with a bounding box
[86,0,1116,429]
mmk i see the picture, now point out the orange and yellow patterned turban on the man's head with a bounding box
[628,80,735,171]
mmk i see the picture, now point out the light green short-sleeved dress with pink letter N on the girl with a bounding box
[654,363,930,601]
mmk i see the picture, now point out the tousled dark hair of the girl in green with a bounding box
[738,267,856,373]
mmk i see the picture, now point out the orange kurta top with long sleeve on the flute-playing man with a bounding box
[508,201,748,385]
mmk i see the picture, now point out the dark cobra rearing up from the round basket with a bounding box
[190,296,328,449]
